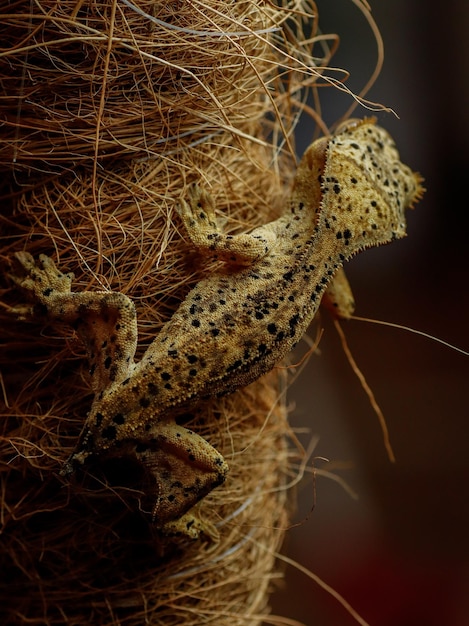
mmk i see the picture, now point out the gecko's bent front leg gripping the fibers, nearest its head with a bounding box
[177,185,276,265]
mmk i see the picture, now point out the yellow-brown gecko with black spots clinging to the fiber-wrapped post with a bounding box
[12,118,423,539]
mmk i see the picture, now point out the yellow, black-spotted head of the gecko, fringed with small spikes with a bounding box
[321,118,424,254]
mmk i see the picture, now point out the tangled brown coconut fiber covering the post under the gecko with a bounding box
[0,0,352,626]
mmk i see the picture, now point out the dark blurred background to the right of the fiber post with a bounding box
[273,0,469,626]
